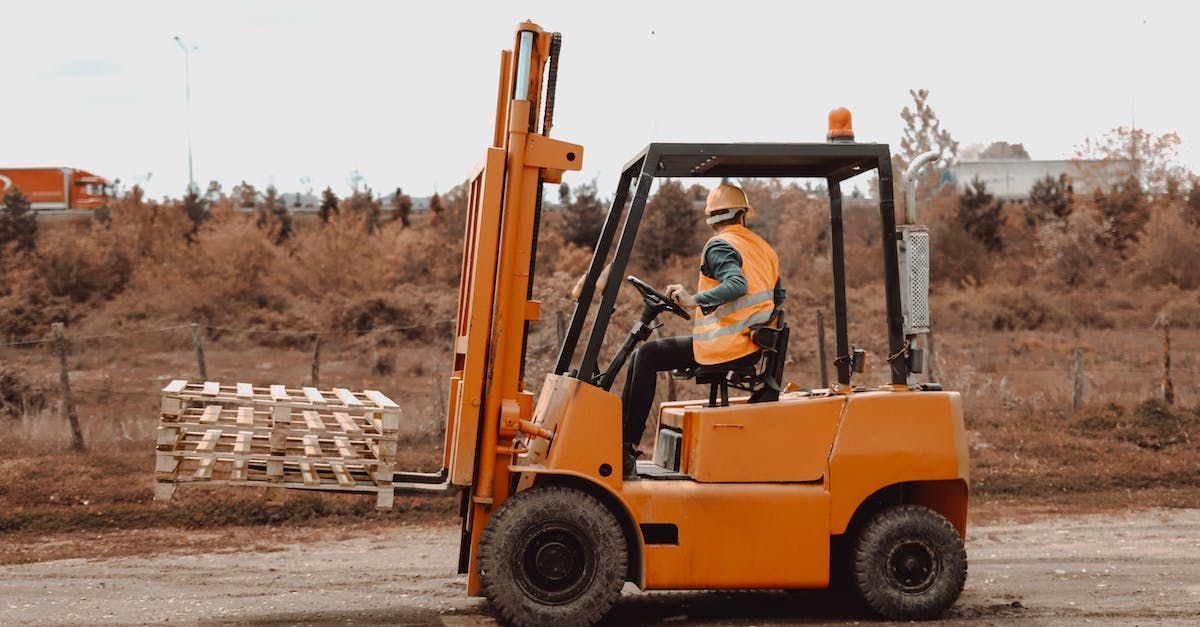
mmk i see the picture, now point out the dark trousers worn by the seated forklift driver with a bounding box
[620,335,758,446]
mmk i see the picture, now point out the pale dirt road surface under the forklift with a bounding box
[0,509,1200,625]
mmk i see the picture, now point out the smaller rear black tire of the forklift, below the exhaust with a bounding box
[852,504,967,620]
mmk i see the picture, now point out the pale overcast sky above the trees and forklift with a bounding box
[0,0,1200,196]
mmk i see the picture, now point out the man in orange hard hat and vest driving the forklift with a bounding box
[622,183,786,480]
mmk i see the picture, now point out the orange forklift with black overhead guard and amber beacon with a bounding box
[436,22,968,625]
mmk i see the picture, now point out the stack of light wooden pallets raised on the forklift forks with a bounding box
[155,381,400,509]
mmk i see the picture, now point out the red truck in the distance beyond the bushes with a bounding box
[0,168,113,210]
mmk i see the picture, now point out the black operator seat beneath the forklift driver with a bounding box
[692,307,791,407]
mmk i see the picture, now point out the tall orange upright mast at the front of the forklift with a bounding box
[443,22,583,562]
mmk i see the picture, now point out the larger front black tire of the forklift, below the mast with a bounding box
[479,488,628,626]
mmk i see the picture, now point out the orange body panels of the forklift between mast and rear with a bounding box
[509,375,967,590]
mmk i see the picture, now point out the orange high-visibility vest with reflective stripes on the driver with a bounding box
[691,225,779,365]
